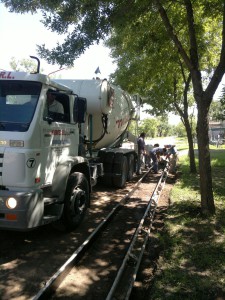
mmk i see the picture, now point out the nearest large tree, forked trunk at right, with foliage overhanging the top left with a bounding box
[1,0,225,215]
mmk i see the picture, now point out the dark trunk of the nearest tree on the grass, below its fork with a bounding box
[197,102,215,215]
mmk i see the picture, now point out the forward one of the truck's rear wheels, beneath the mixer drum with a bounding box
[113,153,128,188]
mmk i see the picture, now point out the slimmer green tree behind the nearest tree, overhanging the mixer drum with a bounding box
[107,6,197,173]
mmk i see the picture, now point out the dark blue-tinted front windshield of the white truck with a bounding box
[0,80,41,132]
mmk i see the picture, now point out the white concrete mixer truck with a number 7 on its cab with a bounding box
[0,63,136,231]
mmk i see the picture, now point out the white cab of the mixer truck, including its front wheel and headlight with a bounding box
[0,71,91,230]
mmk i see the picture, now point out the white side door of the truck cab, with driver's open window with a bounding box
[42,92,79,184]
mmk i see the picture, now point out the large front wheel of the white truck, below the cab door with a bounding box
[63,172,89,230]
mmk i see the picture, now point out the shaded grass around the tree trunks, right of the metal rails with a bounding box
[151,149,225,300]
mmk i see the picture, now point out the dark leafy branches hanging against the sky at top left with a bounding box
[0,0,114,66]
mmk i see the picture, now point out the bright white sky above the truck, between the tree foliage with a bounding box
[0,4,116,79]
